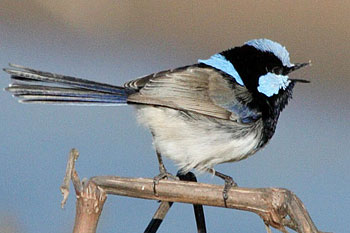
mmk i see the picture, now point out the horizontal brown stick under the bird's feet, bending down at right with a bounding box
[90,176,319,233]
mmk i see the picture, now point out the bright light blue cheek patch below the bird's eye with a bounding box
[258,72,290,97]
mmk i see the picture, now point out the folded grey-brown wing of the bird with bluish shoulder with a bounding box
[125,66,260,123]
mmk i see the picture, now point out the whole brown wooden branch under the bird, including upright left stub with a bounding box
[61,149,326,233]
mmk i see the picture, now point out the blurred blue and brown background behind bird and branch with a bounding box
[0,0,350,233]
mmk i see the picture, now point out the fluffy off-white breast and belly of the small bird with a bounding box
[137,106,262,172]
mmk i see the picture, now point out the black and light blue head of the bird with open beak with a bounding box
[199,39,310,98]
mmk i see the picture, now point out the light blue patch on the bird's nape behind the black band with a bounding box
[198,53,244,86]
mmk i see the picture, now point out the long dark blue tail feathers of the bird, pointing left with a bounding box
[4,64,133,105]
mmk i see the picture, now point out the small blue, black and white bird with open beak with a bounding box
[4,39,310,200]
